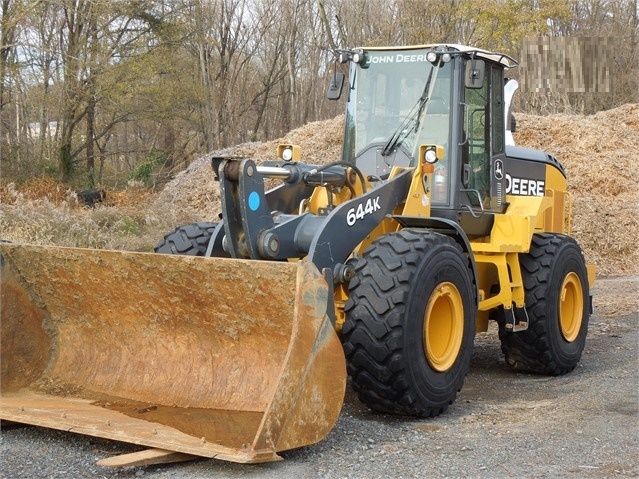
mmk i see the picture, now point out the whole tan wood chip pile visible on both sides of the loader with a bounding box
[154,104,639,276]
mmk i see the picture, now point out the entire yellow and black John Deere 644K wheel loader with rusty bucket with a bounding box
[0,45,595,463]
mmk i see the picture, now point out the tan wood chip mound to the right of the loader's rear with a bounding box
[515,104,639,276]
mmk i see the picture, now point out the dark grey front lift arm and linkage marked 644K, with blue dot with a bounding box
[209,158,412,271]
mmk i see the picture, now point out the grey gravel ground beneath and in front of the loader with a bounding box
[0,277,639,479]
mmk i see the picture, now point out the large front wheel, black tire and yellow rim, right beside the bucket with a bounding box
[342,229,476,417]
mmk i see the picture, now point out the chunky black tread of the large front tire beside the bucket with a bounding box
[342,229,476,417]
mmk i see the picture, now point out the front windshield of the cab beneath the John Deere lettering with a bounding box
[344,49,452,169]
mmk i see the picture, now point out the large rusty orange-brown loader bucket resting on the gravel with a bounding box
[0,244,346,463]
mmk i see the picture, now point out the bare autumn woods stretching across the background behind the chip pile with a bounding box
[0,0,639,188]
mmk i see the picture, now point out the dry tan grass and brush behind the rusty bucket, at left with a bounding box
[0,179,194,251]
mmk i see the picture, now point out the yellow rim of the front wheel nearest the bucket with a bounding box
[424,282,464,372]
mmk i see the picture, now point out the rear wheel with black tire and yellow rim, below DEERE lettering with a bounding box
[499,233,590,376]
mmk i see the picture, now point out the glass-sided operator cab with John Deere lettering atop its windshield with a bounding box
[337,45,517,236]
